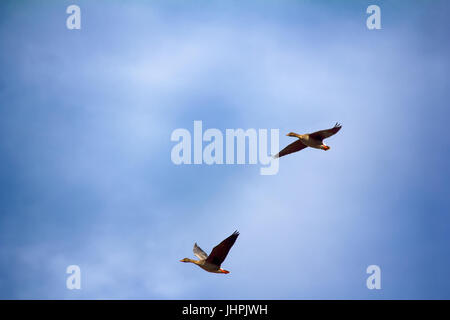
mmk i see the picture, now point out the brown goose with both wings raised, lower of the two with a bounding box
[180,231,239,274]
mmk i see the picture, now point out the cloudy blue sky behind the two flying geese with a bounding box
[0,0,450,299]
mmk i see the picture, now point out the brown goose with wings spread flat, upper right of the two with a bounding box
[273,122,342,158]
